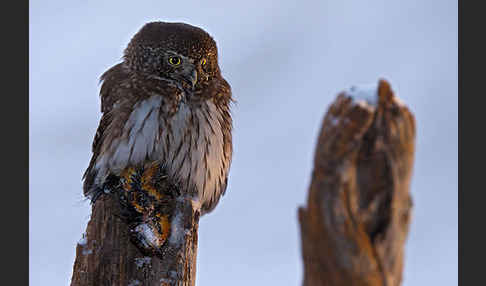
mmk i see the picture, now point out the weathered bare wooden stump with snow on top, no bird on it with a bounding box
[298,80,415,286]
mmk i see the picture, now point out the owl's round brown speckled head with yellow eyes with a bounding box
[124,22,220,89]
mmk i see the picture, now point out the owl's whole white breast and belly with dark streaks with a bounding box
[96,96,231,209]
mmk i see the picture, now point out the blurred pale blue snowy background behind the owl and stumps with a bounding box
[29,0,458,286]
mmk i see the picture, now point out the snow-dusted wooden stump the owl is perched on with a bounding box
[71,192,199,286]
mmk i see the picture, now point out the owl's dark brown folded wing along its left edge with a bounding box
[83,64,128,197]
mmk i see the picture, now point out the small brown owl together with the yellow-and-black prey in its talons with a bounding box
[83,22,232,255]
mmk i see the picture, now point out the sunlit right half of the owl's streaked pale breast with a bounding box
[159,101,230,210]
